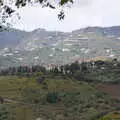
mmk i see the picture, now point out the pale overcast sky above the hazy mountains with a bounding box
[10,0,120,32]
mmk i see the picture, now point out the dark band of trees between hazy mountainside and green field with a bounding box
[0,59,120,83]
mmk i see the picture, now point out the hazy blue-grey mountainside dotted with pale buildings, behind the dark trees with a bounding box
[0,26,120,67]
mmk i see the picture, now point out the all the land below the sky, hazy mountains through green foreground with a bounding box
[0,26,120,120]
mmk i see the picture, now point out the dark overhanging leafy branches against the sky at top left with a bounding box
[0,0,73,28]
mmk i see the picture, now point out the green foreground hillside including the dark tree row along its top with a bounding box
[0,59,120,120]
